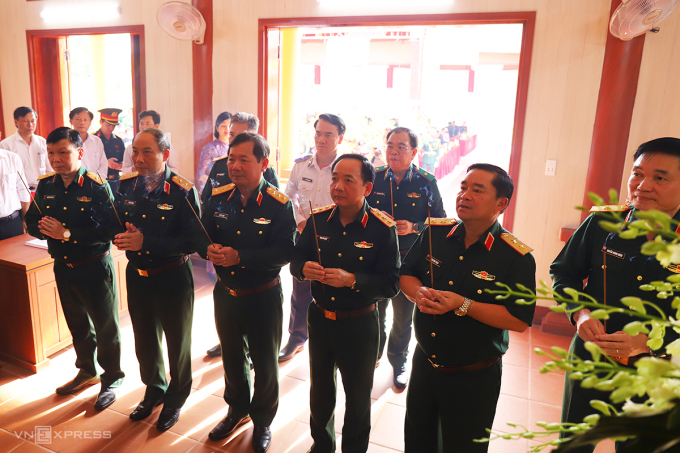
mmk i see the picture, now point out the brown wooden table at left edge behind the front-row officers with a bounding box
[0,234,128,373]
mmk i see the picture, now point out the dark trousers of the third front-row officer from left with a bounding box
[213,282,283,427]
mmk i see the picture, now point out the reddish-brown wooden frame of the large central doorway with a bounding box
[257,11,536,230]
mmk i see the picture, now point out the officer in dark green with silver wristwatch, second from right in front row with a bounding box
[400,164,536,453]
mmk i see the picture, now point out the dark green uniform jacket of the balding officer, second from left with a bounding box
[116,165,205,270]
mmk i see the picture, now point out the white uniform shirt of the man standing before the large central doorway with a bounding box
[286,154,339,223]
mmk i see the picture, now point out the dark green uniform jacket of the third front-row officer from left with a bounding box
[195,178,297,289]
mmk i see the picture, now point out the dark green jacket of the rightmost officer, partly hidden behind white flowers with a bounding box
[550,208,680,344]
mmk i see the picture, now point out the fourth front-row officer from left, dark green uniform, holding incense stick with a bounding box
[290,154,400,453]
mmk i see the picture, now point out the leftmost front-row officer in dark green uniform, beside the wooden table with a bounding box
[26,127,125,410]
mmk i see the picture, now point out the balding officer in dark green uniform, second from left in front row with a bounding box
[114,128,199,431]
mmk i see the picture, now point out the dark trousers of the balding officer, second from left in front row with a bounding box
[126,260,194,408]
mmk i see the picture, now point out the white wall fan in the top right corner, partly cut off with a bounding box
[609,0,680,41]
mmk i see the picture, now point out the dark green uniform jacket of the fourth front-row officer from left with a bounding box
[290,201,399,311]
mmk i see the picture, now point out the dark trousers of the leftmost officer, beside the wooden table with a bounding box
[54,254,125,388]
